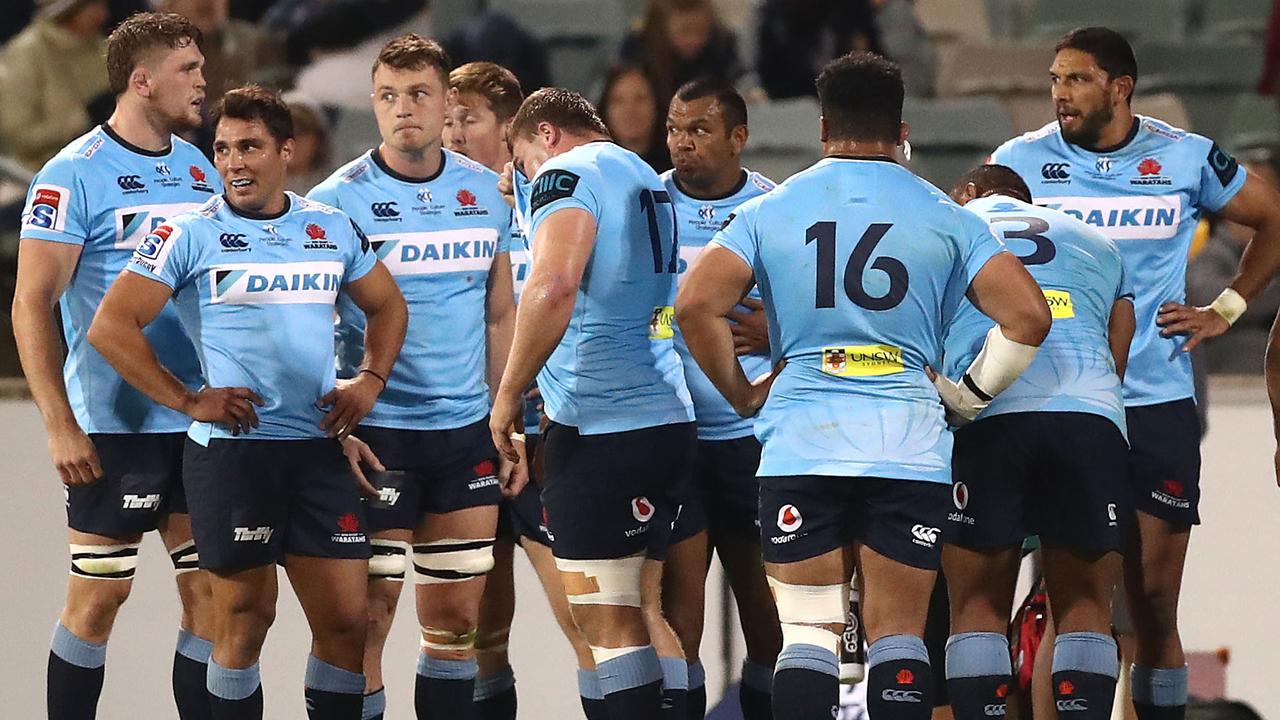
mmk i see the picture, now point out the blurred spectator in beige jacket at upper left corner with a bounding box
[0,0,114,170]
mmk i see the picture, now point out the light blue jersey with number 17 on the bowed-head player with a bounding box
[527,141,694,434]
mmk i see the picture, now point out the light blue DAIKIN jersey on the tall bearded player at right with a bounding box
[991,115,1247,406]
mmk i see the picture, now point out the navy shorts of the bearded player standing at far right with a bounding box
[1125,398,1201,528]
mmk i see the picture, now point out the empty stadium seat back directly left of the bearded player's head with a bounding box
[937,42,1053,97]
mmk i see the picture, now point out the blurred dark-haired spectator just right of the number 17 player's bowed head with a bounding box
[596,65,671,173]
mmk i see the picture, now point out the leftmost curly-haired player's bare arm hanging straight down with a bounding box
[13,238,102,486]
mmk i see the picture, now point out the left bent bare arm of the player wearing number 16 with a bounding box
[676,245,782,418]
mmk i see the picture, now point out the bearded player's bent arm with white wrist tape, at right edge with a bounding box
[1156,168,1280,352]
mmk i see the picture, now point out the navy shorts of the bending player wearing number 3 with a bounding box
[946,413,1133,552]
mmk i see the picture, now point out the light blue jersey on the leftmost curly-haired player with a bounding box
[22,126,223,433]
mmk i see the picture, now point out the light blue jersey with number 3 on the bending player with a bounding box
[945,196,1133,432]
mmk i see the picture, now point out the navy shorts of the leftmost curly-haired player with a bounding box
[65,433,187,538]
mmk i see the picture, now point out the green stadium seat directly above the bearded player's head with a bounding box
[1028,0,1185,42]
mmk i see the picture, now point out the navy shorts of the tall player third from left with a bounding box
[356,418,502,533]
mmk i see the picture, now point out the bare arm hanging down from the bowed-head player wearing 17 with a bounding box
[489,208,596,462]
